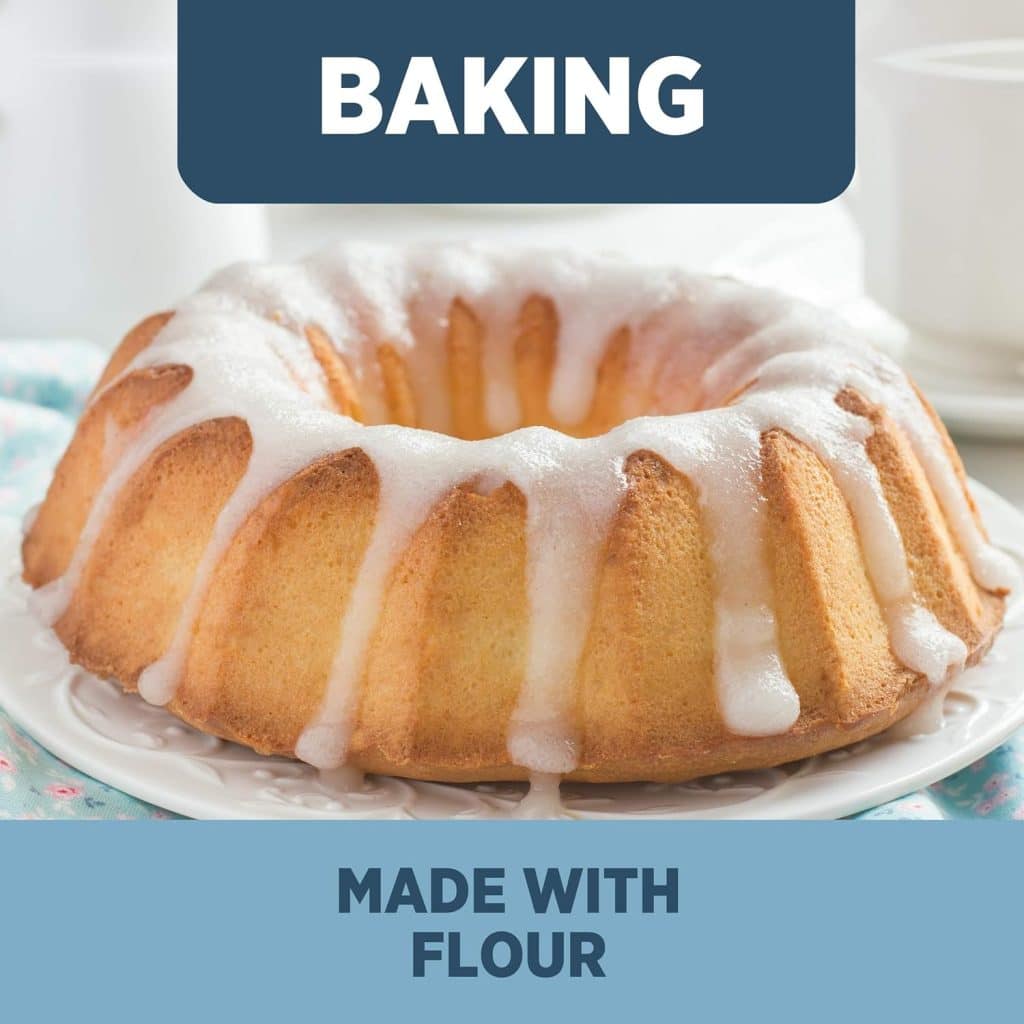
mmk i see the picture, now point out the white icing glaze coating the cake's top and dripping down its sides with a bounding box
[37,246,1012,778]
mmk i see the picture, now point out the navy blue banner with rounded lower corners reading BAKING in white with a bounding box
[178,0,854,203]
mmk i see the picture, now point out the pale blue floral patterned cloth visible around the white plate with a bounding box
[0,341,1024,820]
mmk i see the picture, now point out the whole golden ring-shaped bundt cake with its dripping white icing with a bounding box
[23,246,1013,781]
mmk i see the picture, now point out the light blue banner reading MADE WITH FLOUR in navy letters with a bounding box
[0,821,1024,1024]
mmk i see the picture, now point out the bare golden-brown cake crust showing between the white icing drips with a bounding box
[24,272,1004,781]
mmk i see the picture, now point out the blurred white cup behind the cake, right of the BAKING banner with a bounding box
[853,38,1024,372]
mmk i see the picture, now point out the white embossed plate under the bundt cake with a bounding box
[0,483,1024,819]
